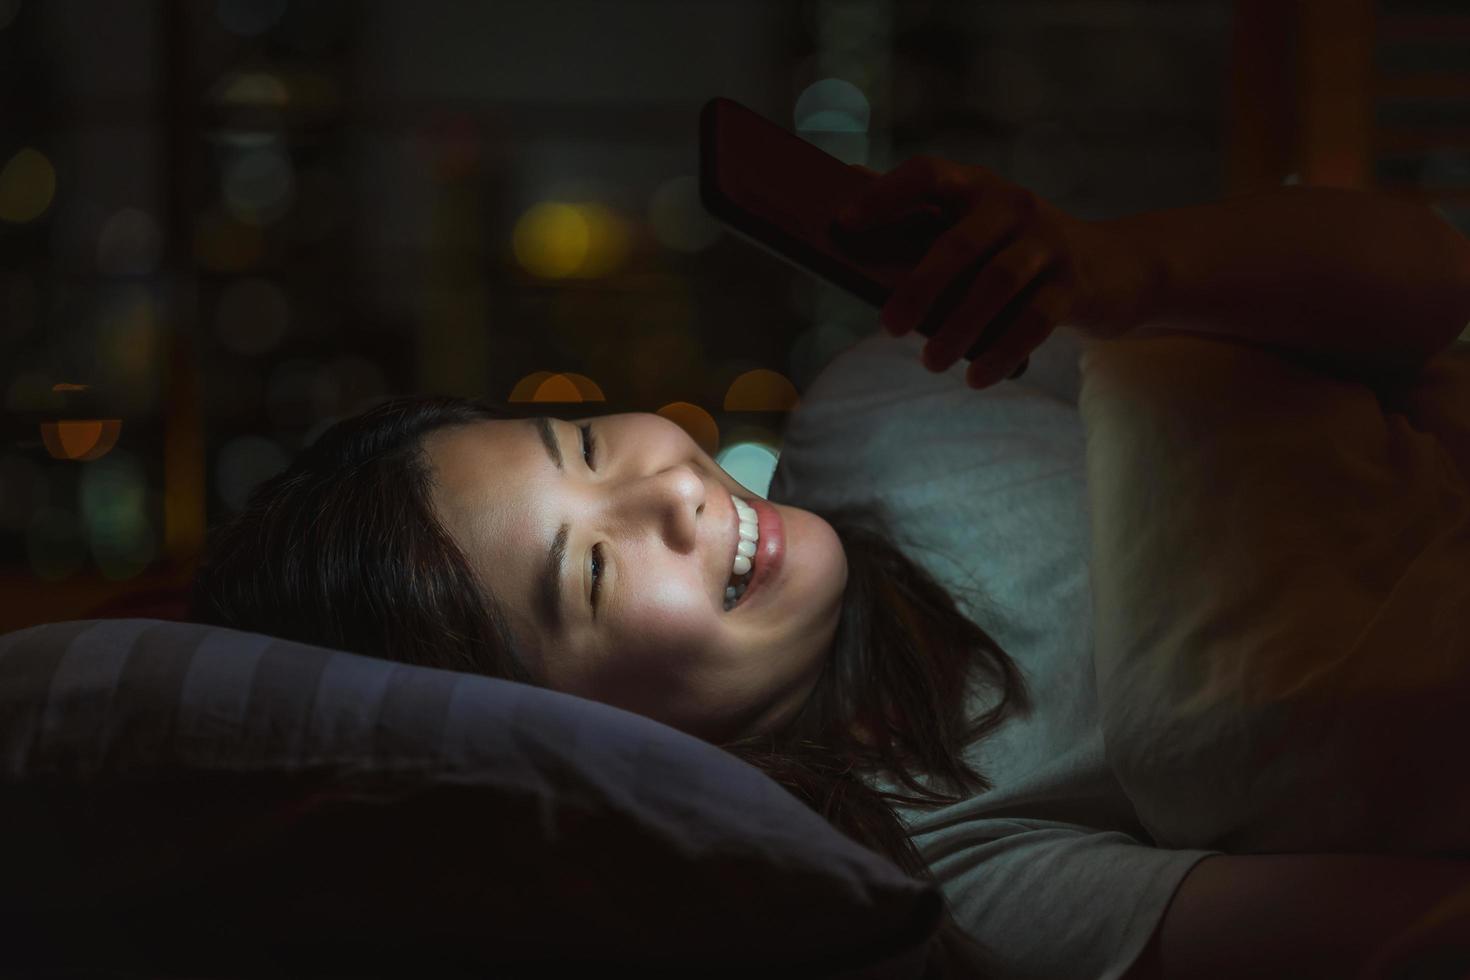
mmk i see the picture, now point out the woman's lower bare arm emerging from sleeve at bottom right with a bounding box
[1123,854,1470,980]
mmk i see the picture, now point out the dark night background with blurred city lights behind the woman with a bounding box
[0,0,1470,630]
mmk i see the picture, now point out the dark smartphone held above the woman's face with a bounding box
[700,98,1029,378]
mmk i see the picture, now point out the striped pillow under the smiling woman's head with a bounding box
[0,619,942,977]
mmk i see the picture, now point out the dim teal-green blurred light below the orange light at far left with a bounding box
[79,451,159,580]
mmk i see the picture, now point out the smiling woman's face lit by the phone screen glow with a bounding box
[425,413,847,741]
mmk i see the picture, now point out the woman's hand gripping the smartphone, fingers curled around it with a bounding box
[838,156,1154,388]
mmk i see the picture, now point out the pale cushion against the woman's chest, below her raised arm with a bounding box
[1079,335,1470,857]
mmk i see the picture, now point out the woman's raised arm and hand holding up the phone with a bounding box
[836,156,1470,388]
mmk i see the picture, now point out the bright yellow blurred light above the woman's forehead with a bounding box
[512,201,632,279]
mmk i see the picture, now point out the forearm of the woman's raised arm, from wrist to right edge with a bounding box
[1103,187,1470,367]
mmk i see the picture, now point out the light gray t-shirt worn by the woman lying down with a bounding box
[769,329,1220,980]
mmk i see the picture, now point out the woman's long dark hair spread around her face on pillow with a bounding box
[190,395,1029,977]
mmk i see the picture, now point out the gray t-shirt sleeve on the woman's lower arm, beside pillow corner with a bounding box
[914,820,1222,980]
